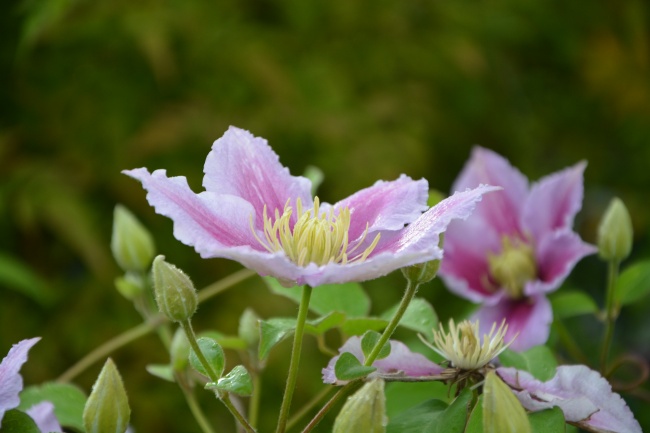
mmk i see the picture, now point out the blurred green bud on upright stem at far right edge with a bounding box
[598,197,633,262]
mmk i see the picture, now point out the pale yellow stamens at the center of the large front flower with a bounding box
[250,197,380,266]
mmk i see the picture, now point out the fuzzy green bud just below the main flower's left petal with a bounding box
[152,256,199,322]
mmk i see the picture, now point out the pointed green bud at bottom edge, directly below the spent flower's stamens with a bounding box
[483,371,531,433]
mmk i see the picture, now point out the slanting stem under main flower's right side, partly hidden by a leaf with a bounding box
[302,279,420,433]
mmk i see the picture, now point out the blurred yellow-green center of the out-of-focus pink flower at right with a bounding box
[488,236,537,299]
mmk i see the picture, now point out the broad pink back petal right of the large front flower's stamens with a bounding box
[334,175,429,241]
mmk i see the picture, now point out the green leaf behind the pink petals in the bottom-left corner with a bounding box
[18,382,86,431]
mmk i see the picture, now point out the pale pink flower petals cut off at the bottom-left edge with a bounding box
[0,337,63,433]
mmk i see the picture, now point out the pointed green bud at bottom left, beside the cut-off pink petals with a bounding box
[83,358,131,433]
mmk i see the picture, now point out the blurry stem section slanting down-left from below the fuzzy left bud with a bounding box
[57,314,167,382]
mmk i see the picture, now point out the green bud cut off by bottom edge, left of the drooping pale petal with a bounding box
[332,379,388,433]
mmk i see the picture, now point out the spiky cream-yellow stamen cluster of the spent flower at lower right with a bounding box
[429,319,514,370]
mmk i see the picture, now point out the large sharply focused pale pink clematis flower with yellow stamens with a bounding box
[124,127,498,286]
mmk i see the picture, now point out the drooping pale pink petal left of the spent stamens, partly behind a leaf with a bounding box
[323,336,443,385]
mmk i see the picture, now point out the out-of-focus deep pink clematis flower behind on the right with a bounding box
[440,147,596,350]
